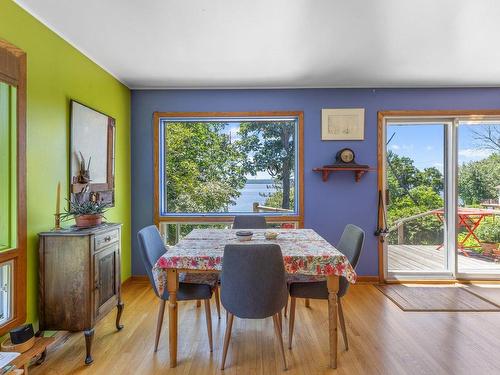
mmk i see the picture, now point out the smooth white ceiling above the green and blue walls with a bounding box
[13,0,500,88]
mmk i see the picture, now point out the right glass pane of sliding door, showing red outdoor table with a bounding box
[456,120,500,277]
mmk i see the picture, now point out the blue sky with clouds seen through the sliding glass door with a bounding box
[387,124,500,172]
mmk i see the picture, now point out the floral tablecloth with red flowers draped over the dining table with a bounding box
[153,229,356,294]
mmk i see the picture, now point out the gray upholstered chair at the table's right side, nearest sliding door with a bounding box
[288,224,365,350]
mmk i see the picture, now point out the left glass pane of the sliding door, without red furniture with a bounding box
[385,120,452,278]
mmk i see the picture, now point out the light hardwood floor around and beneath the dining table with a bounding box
[30,282,500,375]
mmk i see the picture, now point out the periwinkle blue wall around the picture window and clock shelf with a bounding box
[131,88,500,275]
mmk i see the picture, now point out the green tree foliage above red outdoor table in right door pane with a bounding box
[458,153,500,205]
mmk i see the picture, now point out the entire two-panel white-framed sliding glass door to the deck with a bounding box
[382,117,500,279]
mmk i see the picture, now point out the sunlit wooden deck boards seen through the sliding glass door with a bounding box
[387,245,500,273]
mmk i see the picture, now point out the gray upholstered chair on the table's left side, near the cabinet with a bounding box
[137,225,218,352]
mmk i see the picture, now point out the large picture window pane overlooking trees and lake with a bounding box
[162,119,297,214]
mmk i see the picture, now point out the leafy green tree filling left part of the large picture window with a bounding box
[165,122,247,213]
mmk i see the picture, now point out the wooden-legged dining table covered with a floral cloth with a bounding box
[152,229,356,368]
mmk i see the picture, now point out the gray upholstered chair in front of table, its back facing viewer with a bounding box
[221,244,288,370]
